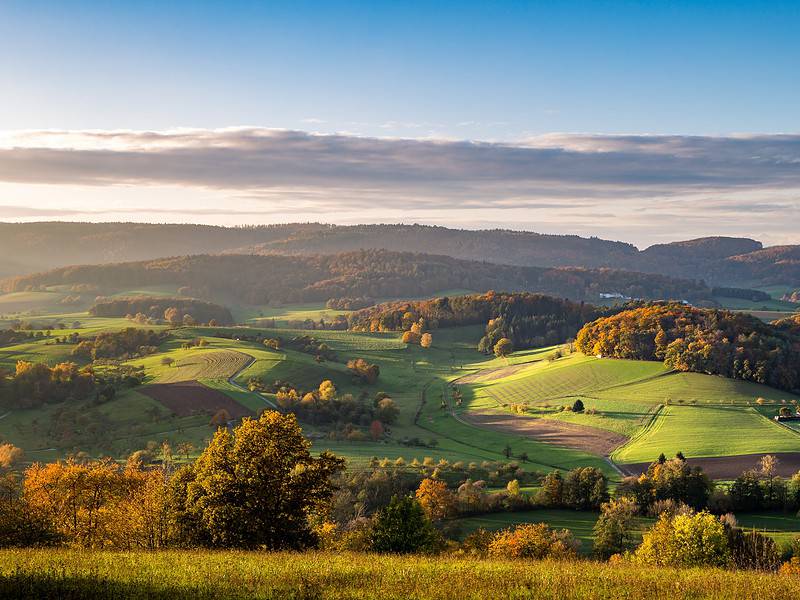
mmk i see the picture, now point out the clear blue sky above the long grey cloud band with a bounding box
[0,1,800,139]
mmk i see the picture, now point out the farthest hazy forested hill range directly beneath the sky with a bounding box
[0,222,800,287]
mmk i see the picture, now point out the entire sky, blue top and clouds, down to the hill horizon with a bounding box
[0,0,800,247]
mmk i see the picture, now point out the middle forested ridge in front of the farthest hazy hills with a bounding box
[0,250,710,304]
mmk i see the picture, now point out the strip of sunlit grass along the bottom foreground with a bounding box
[0,550,800,599]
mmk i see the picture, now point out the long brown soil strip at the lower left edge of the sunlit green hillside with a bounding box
[460,411,628,456]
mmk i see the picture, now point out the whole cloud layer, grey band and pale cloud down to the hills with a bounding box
[0,128,800,242]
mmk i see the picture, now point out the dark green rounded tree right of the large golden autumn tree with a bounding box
[372,496,440,554]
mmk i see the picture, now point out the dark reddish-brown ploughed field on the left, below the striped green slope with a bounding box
[140,381,252,419]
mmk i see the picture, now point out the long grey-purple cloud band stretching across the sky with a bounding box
[0,128,800,195]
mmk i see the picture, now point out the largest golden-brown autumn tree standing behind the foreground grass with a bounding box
[173,411,344,550]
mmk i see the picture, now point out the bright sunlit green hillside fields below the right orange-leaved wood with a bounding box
[457,354,800,463]
